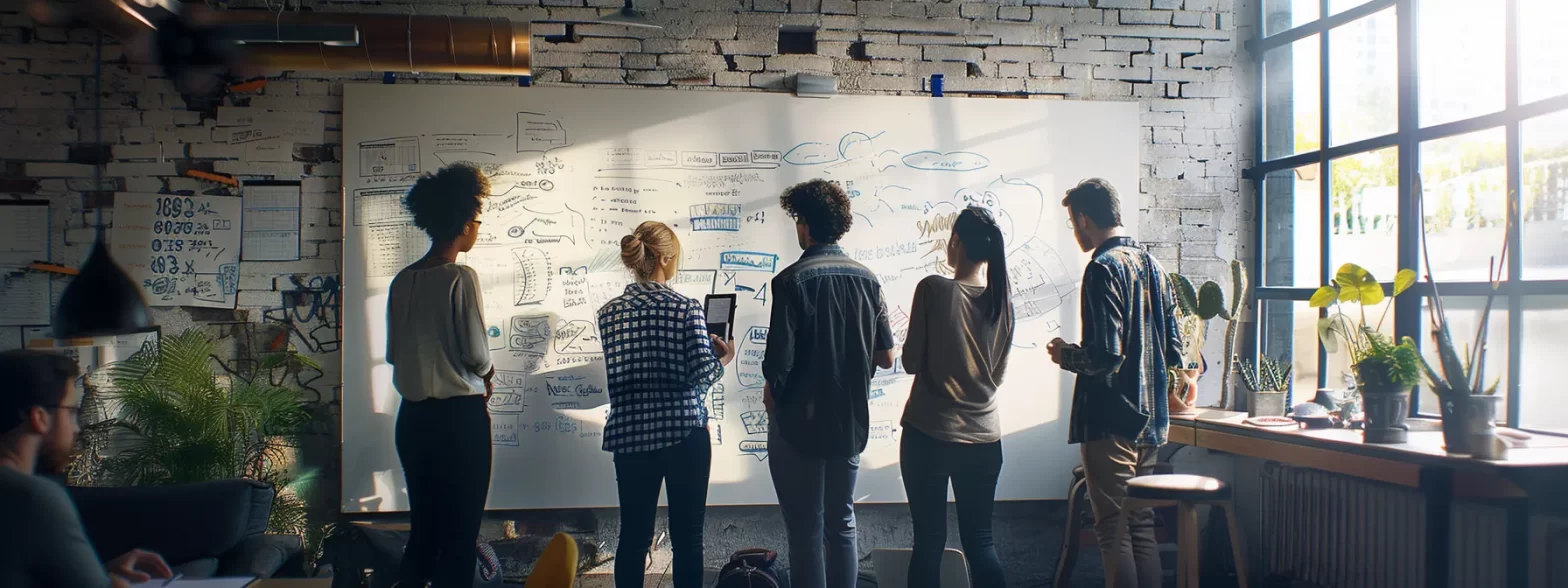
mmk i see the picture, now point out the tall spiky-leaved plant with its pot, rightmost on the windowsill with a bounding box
[1406,176,1518,459]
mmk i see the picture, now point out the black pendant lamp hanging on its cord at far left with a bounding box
[53,33,152,339]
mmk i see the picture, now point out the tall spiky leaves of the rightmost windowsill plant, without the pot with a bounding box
[1405,174,1518,405]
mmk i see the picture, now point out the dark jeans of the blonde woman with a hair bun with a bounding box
[615,428,713,588]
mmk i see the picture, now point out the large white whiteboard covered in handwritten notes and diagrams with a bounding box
[342,85,1140,511]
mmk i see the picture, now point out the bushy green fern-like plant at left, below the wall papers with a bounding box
[102,329,320,535]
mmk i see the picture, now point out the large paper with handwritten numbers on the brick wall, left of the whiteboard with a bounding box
[110,193,241,309]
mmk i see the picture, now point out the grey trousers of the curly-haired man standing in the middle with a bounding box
[768,422,861,588]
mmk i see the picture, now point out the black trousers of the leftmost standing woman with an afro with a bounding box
[395,395,491,588]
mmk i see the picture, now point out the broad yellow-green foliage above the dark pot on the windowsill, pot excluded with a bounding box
[1309,263,1421,392]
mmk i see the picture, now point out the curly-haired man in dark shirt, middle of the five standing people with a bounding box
[762,179,894,588]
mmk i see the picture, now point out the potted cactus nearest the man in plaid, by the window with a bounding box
[1171,260,1247,409]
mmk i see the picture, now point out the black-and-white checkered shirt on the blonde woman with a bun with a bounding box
[599,282,724,453]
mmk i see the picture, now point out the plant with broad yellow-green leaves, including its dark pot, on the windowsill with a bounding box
[1309,263,1421,444]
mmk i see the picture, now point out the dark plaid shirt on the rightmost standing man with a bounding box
[1062,237,1181,447]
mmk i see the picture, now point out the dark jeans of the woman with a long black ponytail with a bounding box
[898,428,1007,588]
